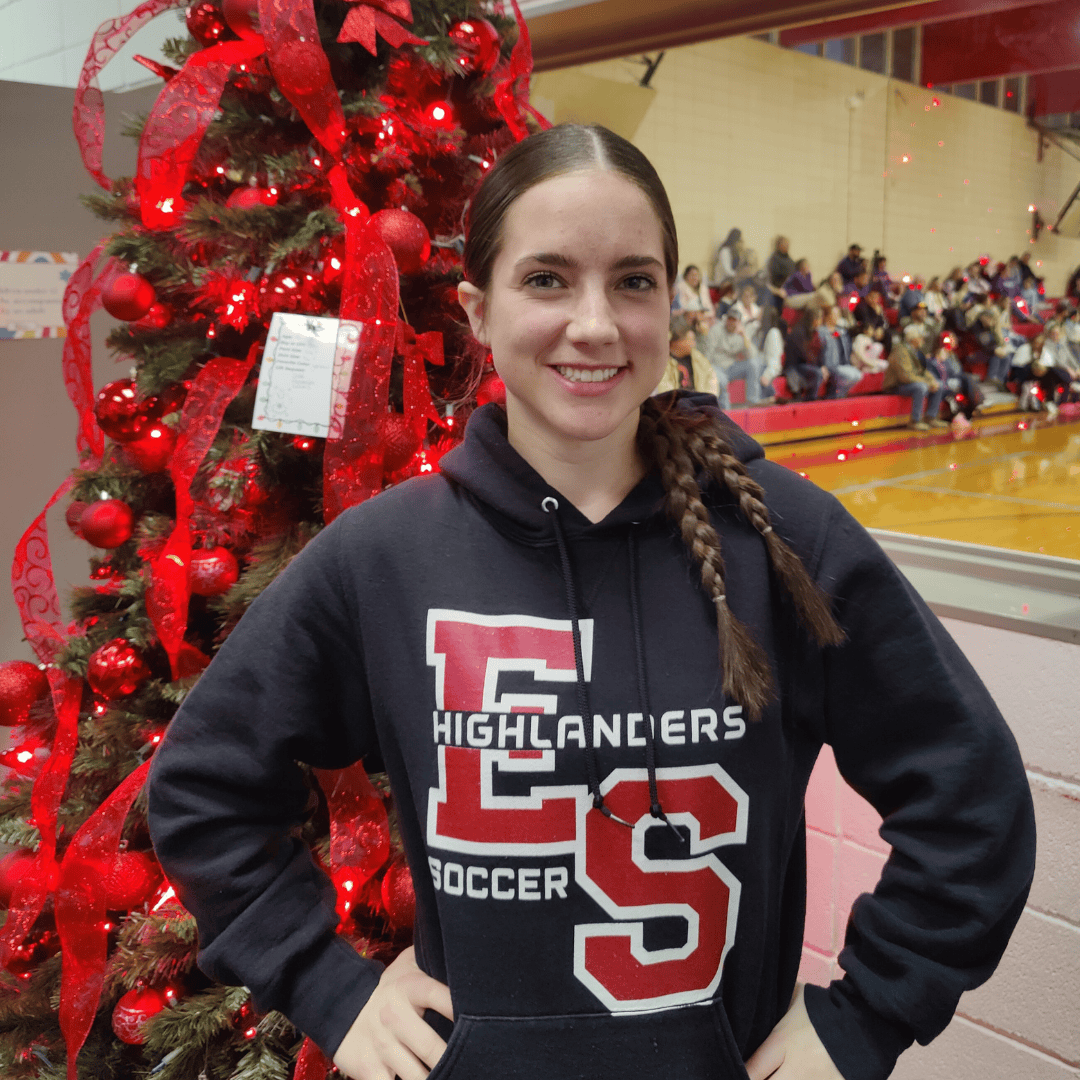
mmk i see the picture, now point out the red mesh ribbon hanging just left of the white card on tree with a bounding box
[146,354,259,678]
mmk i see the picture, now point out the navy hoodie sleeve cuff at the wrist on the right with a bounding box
[805,980,914,1080]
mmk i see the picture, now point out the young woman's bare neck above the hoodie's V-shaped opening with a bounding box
[507,397,645,523]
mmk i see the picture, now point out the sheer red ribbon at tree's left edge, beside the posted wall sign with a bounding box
[63,240,120,469]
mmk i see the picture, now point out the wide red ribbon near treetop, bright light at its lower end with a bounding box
[135,37,264,229]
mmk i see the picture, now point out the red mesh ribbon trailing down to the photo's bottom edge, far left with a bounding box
[55,760,150,1080]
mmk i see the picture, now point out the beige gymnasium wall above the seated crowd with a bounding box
[534,38,1080,295]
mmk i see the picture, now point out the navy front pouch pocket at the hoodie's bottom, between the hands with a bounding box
[428,1002,747,1080]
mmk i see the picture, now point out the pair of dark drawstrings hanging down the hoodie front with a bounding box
[540,496,686,843]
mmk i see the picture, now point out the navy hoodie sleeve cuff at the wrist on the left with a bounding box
[281,934,382,1057]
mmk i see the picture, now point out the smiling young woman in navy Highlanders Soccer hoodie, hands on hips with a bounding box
[150,126,1034,1080]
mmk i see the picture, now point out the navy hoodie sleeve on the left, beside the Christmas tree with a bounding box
[149,515,381,1054]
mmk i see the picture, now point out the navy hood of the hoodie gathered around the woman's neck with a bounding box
[440,390,765,546]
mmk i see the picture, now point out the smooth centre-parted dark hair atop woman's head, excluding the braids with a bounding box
[462,124,678,289]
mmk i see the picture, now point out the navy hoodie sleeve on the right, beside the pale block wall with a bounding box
[806,504,1035,1080]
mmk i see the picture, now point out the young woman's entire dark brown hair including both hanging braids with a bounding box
[463,124,843,719]
